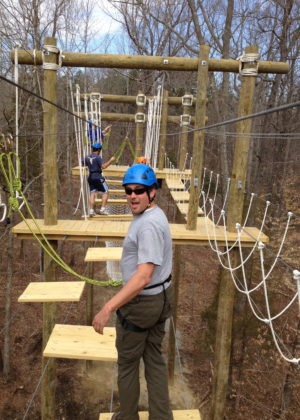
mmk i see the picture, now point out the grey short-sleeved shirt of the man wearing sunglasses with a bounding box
[121,206,172,295]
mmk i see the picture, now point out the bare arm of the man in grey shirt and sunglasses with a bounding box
[92,263,155,334]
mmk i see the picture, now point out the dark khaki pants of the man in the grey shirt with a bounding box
[116,286,173,420]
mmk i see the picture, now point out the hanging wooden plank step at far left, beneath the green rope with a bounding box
[18,281,85,302]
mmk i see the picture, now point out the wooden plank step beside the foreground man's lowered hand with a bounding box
[43,324,117,362]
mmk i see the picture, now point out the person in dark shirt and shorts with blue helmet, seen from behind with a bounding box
[83,142,116,217]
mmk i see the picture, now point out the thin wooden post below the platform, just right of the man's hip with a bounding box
[168,245,181,384]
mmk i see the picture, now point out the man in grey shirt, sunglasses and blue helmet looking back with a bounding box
[93,164,173,420]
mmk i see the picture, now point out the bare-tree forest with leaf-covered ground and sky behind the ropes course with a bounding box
[0,0,300,420]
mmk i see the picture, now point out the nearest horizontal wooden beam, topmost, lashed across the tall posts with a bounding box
[10,49,289,74]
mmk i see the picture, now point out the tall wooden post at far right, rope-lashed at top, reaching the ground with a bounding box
[211,46,258,420]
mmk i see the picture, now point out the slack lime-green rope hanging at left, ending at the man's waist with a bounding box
[0,152,122,287]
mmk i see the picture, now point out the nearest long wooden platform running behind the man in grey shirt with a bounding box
[12,217,269,247]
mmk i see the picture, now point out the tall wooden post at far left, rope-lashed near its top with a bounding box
[41,38,57,420]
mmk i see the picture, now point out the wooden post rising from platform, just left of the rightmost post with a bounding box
[186,45,209,230]
